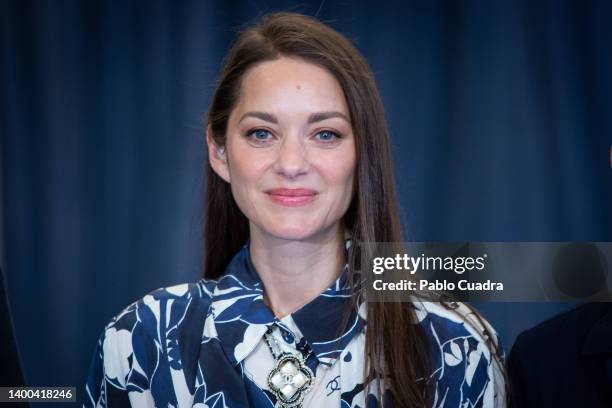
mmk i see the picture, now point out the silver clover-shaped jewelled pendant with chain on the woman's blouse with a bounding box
[264,327,314,408]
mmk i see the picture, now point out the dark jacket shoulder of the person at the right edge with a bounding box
[508,303,612,408]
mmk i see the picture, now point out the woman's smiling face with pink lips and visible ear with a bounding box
[208,57,356,240]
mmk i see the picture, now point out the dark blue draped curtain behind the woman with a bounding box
[0,0,612,394]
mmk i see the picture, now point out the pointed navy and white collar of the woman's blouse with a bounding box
[212,240,365,366]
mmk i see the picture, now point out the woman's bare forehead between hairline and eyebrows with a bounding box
[236,57,349,116]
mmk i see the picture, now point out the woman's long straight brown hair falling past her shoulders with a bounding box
[204,13,504,407]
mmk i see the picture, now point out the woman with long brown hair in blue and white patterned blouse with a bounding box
[85,13,505,407]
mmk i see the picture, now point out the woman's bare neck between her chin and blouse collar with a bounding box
[249,225,345,318]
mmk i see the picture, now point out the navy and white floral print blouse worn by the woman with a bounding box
[84,241,505,408]
